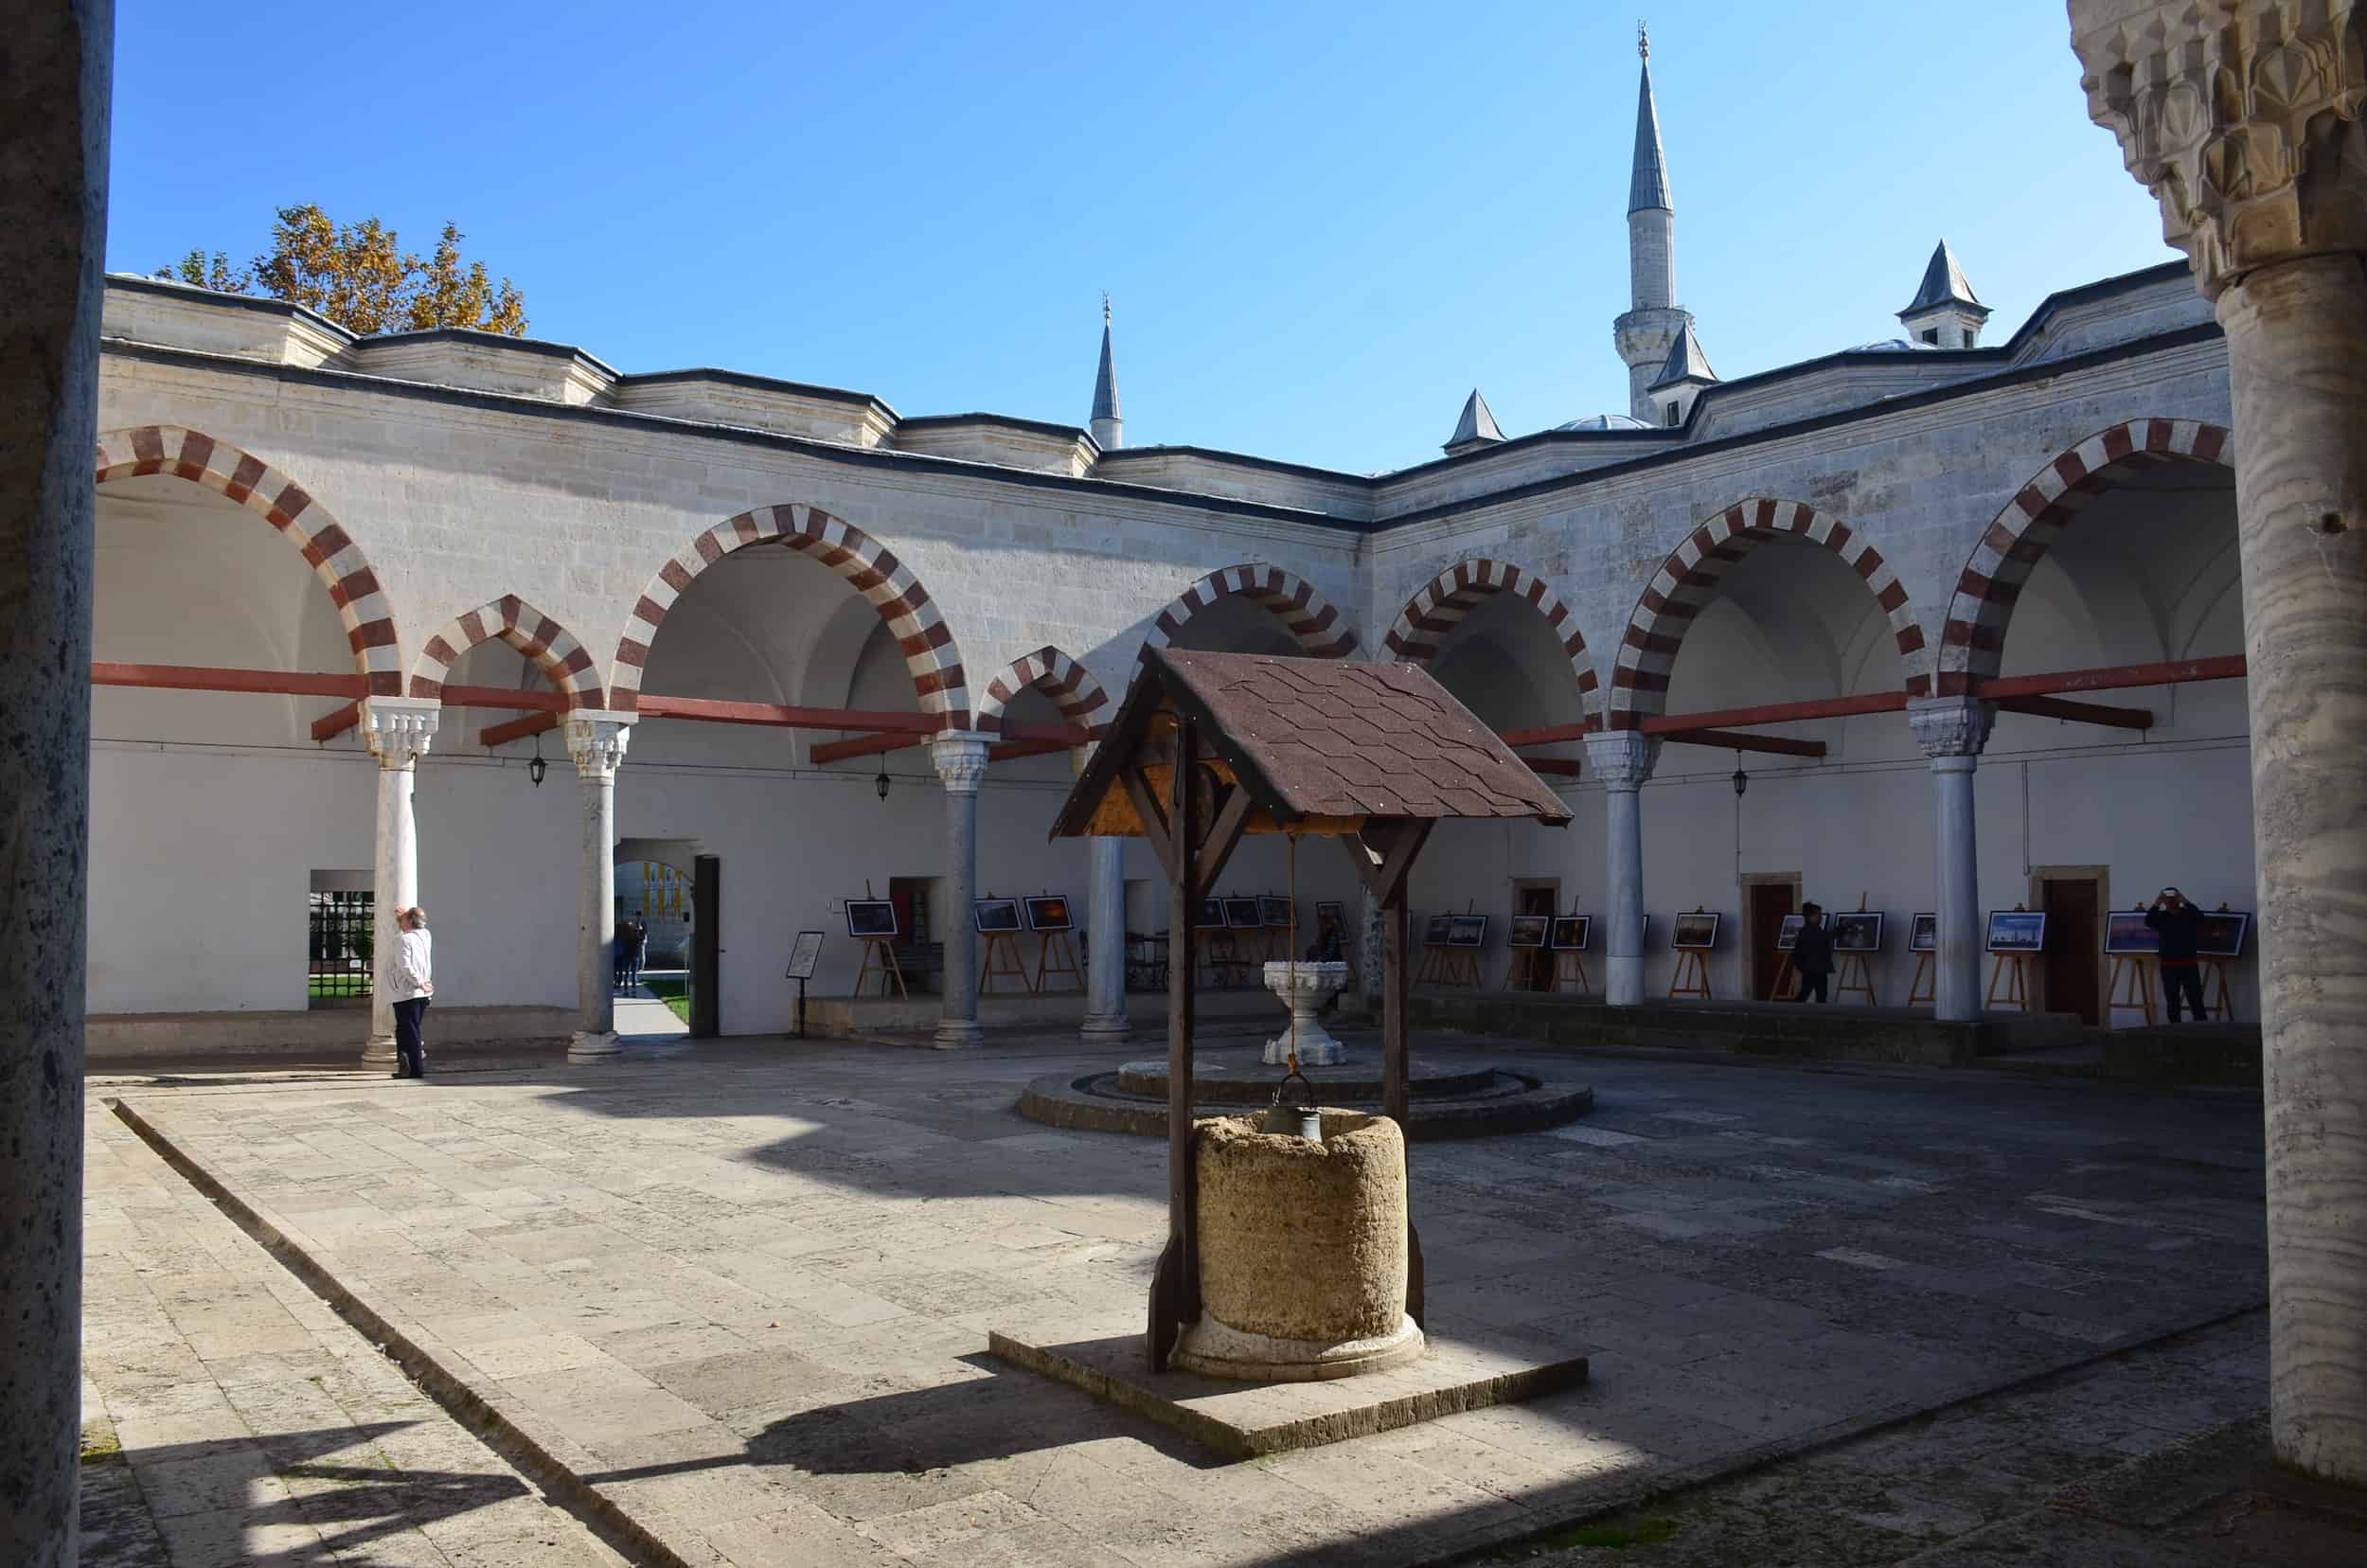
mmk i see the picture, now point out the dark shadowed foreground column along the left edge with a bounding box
[0,0,114,1568]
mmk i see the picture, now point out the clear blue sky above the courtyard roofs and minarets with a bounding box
[109,0,2176,472]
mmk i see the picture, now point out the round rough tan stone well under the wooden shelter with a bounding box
[1169,1111,1423,1383]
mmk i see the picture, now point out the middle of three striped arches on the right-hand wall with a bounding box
[1603,497,1931,729]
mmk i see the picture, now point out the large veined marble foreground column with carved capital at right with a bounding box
[2072,0,2367,1485]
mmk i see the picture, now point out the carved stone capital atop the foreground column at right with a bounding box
[2072,0,2367,298]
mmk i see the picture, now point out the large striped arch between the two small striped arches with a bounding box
[609,505,970,729]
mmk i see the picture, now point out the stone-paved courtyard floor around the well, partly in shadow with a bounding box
[90,1040,2266,1565]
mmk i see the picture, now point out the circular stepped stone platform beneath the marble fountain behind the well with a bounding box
[1018,1047,1595,1142]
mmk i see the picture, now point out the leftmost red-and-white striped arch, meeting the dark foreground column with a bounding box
[95,424,402,696]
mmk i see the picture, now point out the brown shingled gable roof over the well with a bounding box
[1054,649,1570,836]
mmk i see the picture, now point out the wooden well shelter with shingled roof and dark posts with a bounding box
[1051,649,1570,1371]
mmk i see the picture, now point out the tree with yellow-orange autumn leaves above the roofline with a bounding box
[156,202,525,336]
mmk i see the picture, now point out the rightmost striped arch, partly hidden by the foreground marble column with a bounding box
[1939,419,2234,696]
